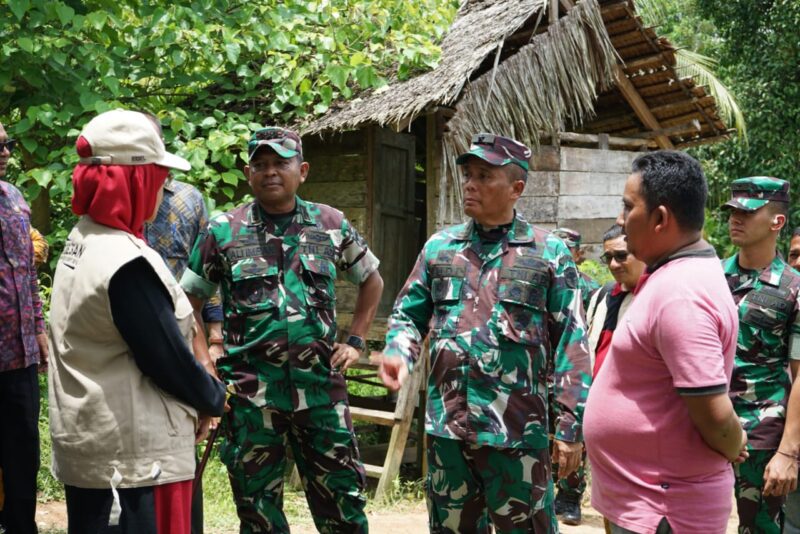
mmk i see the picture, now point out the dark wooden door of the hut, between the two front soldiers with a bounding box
[371,127,422,317]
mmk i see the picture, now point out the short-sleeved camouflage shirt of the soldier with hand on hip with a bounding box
[181,198,378,411]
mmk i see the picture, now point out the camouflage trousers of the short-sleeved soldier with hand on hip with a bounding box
[220,398,368,534]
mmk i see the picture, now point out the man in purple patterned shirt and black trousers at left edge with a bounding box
[0,124,48,534]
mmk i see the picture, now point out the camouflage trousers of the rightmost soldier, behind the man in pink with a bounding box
[733,450,785,534]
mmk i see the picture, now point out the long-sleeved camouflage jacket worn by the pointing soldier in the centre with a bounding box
[384,216,591,448]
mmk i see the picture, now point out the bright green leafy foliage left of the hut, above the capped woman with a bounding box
[0,0,457,262]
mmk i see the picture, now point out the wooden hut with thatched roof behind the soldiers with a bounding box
[301,0,728,326]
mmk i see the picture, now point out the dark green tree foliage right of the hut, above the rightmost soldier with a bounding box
[694,0,800,253]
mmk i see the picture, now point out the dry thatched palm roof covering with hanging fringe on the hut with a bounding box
[303,0,616,138]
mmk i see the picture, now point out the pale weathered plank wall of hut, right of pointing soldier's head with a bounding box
[518,146,640,258]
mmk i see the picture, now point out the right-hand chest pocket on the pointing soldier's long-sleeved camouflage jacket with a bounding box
[497,257,550,344]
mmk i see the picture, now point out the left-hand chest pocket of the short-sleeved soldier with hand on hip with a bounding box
[231,258,280,314]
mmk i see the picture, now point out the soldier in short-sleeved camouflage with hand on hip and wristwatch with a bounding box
[181,128,383,533]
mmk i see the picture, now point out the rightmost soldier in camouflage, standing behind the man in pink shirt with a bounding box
[723,177,800,533]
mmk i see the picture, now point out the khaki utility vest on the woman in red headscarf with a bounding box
[49,216,197,488]
